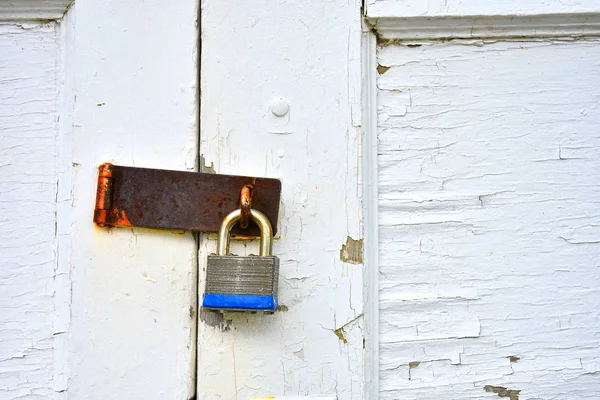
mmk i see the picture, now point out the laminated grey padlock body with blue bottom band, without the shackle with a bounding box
[202,256,279,312]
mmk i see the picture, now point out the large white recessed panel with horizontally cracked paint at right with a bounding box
[377,39,600,400]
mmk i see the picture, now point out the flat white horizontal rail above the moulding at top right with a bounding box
[366,0,600,18]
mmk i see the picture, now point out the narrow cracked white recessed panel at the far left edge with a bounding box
[0,23,59,399]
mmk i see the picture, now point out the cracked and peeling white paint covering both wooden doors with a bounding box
[0,0,600,400]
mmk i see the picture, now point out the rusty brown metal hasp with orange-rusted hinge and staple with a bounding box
[94,163,281,237]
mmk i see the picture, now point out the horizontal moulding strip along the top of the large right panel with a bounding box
[367,12,600,40]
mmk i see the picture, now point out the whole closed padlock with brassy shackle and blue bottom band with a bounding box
[202,210,279,313]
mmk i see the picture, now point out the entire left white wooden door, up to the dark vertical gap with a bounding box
[0,0,198,400]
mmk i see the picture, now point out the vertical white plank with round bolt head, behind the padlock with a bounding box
[198,0,364,400]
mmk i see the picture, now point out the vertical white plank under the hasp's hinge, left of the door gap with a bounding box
[64,0,198,399]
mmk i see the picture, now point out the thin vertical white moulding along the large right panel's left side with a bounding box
[361,23,379,400]
